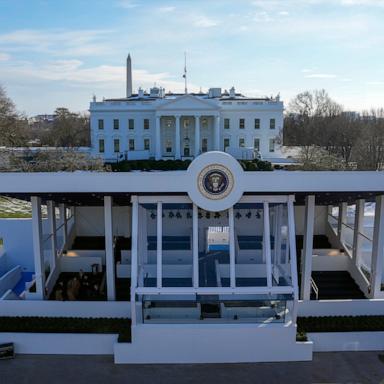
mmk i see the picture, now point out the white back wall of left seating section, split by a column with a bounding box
[75,207,131,237]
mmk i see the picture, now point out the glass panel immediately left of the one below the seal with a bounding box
[162,204,193,287]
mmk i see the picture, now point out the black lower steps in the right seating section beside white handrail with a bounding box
[311,271,365,300]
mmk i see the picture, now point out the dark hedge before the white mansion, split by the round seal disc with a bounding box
[108,159,273,172]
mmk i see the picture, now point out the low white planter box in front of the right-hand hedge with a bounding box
[307,332,384,352]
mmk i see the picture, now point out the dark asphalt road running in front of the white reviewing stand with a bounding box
[0,352,384,384]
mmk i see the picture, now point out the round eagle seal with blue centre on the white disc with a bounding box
[197,164,233,200]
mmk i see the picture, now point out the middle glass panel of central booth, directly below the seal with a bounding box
[198,209,230,287]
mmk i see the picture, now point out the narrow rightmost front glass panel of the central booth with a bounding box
[269,204,292,286]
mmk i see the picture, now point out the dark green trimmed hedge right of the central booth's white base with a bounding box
[297,316,384,334]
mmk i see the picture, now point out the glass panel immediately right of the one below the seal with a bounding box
[234,203,267,287]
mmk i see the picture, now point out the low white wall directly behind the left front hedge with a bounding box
[0,300,131,318]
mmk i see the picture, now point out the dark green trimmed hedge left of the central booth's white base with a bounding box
[0,316,131,342]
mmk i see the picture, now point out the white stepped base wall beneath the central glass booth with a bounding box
[114,324,312,364]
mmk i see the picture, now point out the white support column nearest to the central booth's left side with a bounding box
[104,196,116,301]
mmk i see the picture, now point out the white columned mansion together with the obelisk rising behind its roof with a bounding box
[89,56,284,161]
